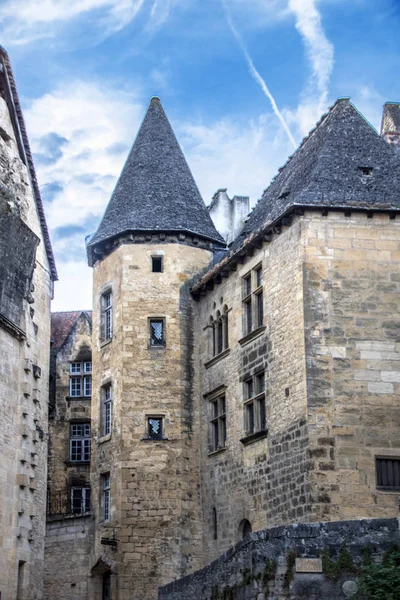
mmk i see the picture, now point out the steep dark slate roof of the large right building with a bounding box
[233,98,400,250]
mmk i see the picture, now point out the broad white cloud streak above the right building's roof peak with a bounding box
[289,0,334,112]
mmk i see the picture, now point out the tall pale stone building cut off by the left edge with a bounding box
[0,47,57,600]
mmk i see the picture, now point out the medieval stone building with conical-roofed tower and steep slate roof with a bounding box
[41,98,400,600]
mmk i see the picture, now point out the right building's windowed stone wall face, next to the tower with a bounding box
[194,221,309,561]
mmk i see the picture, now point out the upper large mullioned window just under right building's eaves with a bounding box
[242,265,264,335]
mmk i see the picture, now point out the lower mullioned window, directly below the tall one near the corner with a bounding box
[244,371,267,436]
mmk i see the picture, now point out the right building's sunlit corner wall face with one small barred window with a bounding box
[304,212,400,519]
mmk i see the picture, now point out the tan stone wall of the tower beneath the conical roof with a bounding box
[91,243,211,600]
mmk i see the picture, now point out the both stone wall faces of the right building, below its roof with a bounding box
[195,212,400,558]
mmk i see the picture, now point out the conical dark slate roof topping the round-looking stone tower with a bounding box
[88,98,225,250]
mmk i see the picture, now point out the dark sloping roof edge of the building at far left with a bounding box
[0,46,58,281]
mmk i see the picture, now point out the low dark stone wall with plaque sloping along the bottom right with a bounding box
[158,519,400,600]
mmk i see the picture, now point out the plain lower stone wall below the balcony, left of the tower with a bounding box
[43,516,93,600]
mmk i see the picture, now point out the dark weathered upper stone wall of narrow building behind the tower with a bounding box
[48,313,92,498]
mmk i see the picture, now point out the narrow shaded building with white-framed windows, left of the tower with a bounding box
[43,311,93,600]
